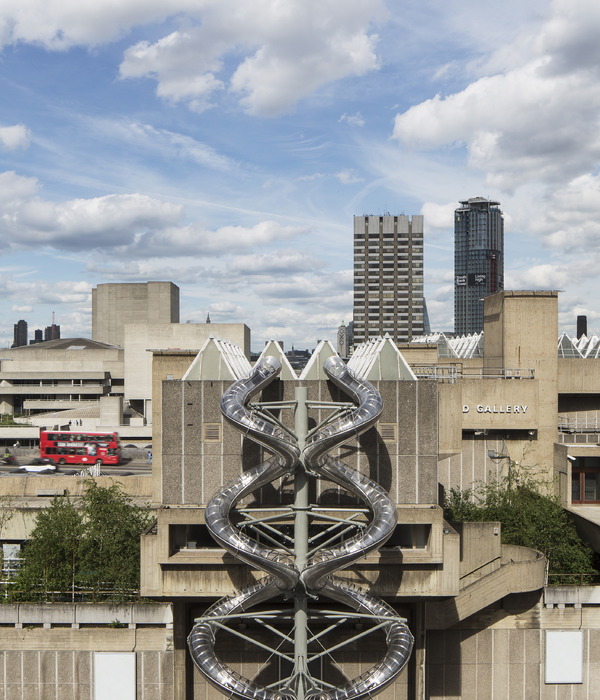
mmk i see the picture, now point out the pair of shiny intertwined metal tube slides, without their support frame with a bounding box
[188,357,413,700]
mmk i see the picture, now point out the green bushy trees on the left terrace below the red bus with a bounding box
[15,479,152,597]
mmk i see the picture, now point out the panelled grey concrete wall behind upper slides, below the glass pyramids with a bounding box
[161,381,438,505]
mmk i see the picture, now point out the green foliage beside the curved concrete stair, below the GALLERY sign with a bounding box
[444,465,598,582]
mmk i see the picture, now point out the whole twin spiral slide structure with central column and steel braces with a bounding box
[188,357,413,700]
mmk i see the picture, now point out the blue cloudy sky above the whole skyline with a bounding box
[0,0,600,350]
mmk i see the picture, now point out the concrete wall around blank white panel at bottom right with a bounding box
[426,593,600,700]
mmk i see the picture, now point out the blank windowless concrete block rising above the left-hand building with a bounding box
[92,282,179,347]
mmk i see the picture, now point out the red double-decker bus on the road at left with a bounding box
[40,430,121,465]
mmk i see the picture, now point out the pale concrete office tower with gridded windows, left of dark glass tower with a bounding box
[354,215,424,345]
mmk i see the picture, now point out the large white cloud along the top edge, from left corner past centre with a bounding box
[0,0,384,115]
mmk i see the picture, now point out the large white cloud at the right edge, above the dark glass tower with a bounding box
[393,0,600,192]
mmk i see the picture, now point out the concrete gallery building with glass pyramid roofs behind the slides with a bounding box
[138,291,600,700]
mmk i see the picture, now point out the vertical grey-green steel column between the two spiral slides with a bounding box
[294,386,309,700]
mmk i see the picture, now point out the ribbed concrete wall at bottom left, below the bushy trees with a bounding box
[0,603,175,700]
